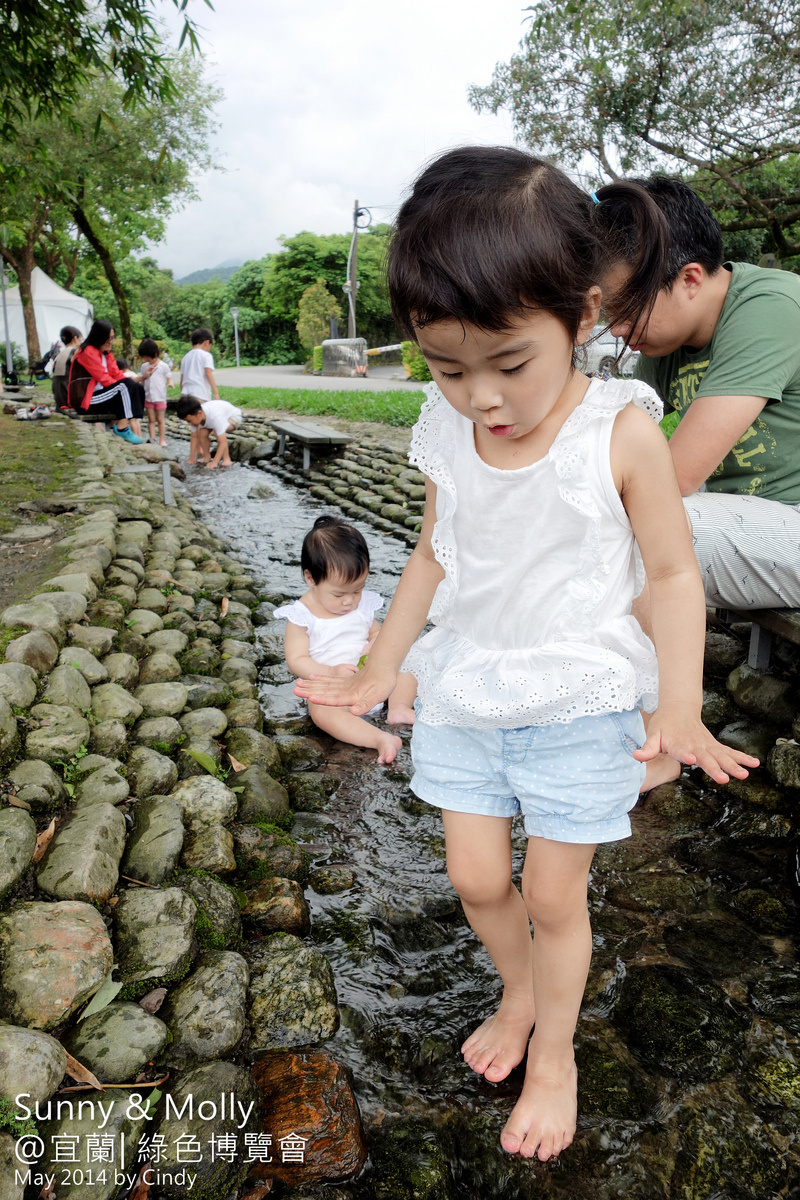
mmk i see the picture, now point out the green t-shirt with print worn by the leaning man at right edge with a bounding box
[637,263,800,504]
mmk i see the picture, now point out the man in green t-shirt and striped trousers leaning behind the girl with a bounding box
[595,175,800,609]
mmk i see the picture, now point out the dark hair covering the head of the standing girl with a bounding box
[389,146,671,342]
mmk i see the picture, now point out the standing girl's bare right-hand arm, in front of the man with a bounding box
[612,404,758,784]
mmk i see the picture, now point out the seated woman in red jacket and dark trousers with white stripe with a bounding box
[67,320,144,445]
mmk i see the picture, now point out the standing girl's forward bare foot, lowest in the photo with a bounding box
[500,1055,578,1163]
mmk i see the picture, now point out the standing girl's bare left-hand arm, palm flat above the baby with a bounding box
[295,479,445,716]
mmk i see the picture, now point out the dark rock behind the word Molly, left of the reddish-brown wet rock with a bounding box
[152,1062,261,1200]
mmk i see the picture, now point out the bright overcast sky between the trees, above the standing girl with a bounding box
[152,0,529,278]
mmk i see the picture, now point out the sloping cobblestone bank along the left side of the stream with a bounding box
[0,415,366,1200]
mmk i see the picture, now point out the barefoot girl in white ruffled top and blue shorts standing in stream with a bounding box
[297,148,757,1160]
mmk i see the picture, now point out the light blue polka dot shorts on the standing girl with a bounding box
[411,709,645,845]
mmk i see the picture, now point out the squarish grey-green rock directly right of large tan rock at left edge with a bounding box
[114,888,197,996]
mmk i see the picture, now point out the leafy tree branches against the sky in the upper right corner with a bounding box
[470,0,800,257]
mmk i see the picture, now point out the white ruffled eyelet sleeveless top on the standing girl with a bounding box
[403,379,662,728]
